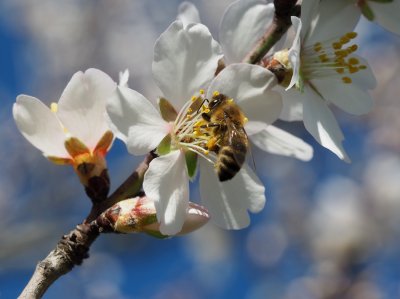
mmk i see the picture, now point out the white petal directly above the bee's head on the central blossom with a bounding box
[207,63,282,124]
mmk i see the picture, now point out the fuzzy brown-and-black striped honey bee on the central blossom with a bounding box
[202,93,249,182]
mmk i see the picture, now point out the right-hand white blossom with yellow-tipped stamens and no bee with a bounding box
[280,0,376,161]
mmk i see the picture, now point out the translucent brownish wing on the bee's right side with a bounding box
[225,117,249,166]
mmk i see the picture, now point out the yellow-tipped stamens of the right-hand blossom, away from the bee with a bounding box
[301,32,367,84]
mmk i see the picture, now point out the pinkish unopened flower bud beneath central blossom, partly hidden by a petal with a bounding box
[96,196,210,238]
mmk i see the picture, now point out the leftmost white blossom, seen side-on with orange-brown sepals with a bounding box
[13,69,115,186]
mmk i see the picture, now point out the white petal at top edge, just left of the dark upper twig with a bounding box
[219,0,275,63]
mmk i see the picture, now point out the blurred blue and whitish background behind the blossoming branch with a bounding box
[0,0,400,299]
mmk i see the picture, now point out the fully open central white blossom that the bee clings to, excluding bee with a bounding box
[107,21,282,235]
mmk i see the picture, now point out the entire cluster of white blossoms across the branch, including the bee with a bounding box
[13,0,400,235]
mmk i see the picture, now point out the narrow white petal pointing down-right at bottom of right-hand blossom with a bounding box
[303,85,350,162]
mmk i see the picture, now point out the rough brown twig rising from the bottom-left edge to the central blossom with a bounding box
[18,153,155,299]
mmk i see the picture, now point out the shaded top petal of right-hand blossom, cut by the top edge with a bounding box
[302,0,360,45]
